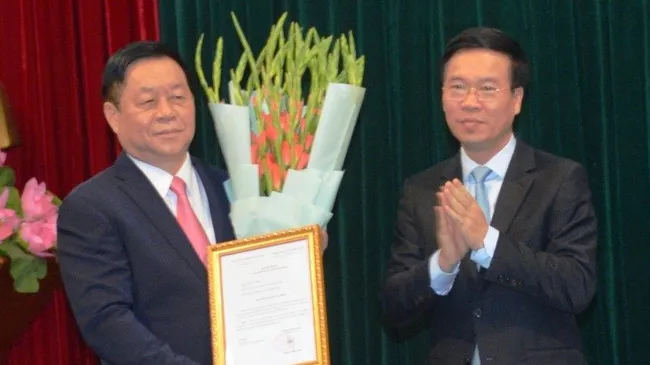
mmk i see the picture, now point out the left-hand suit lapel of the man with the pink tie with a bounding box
[115,153,207,285]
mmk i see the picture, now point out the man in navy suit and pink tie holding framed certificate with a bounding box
[58,42,234,365]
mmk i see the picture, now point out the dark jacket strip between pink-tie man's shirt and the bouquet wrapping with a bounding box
[192,158,235,243]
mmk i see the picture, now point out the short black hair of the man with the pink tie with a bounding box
[102,41,190,105]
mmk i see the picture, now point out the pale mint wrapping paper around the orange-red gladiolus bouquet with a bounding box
[210,84,365,239]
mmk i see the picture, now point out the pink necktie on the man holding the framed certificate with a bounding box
[170,176,210,265]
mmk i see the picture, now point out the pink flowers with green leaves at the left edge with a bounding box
[0,151,61,293]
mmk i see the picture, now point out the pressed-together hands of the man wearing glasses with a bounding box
[434,179,488,272]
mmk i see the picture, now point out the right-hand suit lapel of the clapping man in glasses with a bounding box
[491,141,535,232]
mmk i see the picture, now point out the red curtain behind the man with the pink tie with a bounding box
[0,0,159,365]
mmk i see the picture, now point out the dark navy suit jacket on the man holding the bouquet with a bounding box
[58,154,234,365]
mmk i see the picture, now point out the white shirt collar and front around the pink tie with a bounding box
[127,154,216,243]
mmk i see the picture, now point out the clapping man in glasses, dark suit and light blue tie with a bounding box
[382,28,597,365]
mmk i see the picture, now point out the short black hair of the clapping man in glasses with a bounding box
[440,27,530,89]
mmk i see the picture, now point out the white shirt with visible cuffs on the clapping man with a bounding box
[429,135,517,295]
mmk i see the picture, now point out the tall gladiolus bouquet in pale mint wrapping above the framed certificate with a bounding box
[195,13,365,238]
